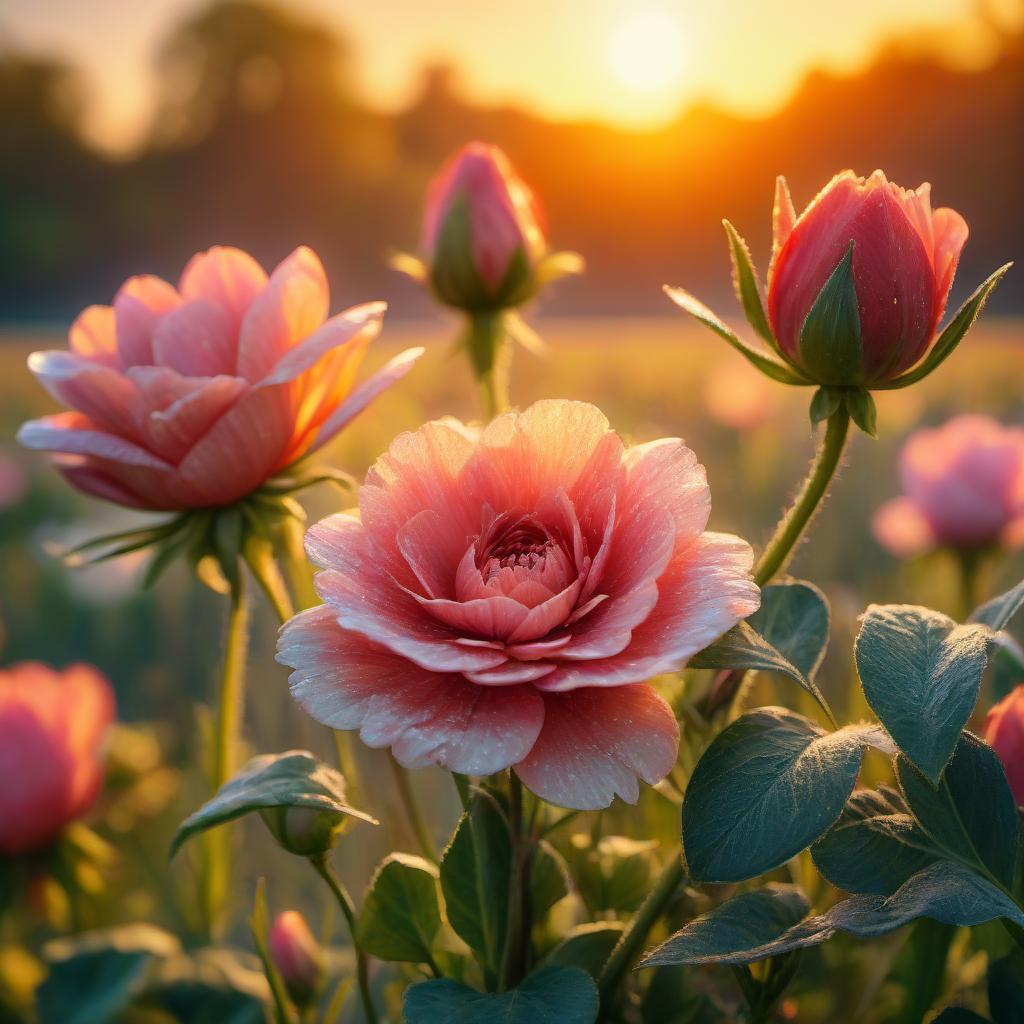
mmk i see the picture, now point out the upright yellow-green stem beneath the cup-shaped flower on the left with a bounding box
[203,571,249,935]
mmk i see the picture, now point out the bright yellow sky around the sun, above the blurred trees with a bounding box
[0,0,1024,150]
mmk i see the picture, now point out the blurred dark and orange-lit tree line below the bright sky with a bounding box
[0,0,1024,323]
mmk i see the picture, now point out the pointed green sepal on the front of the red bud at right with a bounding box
[798,242,864,385]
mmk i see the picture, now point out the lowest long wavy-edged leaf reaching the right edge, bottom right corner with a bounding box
[684,860,1024,963]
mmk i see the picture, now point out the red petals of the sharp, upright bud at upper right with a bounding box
[768,171,968,385]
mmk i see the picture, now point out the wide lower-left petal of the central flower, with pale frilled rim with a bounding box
[278,606,544,775]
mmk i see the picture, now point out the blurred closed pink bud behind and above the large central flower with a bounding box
[423,142,547,311]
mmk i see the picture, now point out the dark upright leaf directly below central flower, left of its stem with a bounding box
[440,793,511,968]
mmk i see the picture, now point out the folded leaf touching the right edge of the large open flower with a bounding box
[689,582,835,722]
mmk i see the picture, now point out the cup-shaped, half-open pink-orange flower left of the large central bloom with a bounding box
[18,247,419,510]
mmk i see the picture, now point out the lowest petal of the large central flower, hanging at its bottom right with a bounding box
[515,683,679,811]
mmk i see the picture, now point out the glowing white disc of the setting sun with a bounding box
[608,7,687,95]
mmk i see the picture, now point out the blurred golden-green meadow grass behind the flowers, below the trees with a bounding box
[0,317,1024,1019]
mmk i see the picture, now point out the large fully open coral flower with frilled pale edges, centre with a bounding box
[278,400,760,809]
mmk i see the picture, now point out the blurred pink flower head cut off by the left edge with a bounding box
[0,662,114,855]
